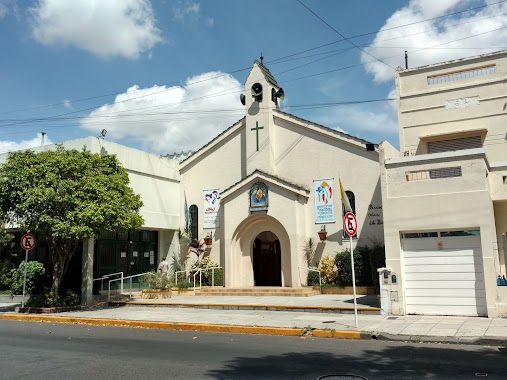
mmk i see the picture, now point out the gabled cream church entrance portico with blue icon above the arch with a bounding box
[220,171,309,287]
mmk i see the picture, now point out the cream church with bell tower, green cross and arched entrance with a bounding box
[179,58,383,287]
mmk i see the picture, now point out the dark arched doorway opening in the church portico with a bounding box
[252,231,282,286]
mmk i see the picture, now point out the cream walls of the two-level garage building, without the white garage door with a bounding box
[380,51,507,316]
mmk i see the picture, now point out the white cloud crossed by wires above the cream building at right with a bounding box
[361,0,507,82]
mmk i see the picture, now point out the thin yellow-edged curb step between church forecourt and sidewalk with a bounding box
[108,301,380,315]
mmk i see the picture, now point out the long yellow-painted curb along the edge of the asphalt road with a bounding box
[0,314,371,339]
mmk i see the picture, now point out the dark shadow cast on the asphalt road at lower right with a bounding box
[207,341,507,380]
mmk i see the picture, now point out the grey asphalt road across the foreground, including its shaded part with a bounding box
[0,321,507,380]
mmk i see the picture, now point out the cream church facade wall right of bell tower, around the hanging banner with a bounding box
[274,115,383,256]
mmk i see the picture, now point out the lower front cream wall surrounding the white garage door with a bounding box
[381,142,499,316]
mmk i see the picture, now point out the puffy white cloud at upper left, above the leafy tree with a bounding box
[30,0,162,59]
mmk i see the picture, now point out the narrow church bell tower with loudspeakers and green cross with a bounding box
[240,54,284,174]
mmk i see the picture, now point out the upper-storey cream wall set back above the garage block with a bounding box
[396,52,507,162]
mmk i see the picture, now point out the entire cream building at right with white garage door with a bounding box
[380,51,507,317]
